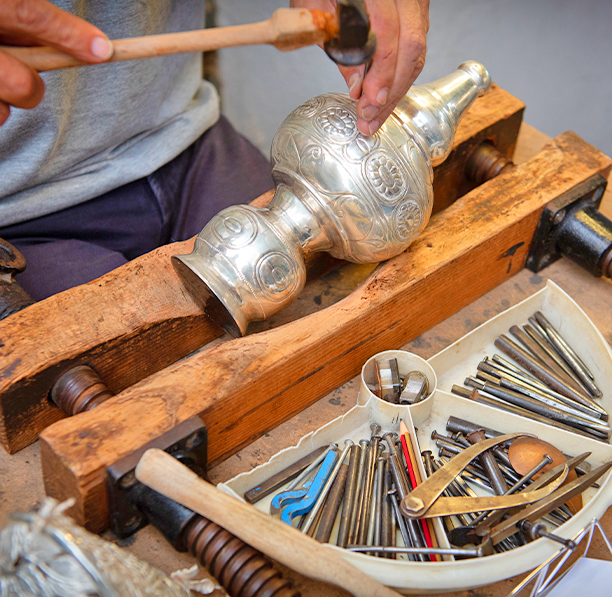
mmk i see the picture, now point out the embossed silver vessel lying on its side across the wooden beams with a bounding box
[172,62,491,336]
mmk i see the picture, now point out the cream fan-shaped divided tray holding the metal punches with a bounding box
[218,281,612,593]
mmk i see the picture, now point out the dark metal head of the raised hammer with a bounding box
[324,0,376,66]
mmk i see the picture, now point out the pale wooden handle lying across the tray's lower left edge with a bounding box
[136,448,399,597]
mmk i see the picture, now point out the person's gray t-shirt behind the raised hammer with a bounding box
[0,0,219,227]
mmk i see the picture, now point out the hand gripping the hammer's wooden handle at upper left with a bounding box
[0,0,113,125]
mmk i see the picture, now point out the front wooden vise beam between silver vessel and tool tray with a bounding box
[41,133,612,531]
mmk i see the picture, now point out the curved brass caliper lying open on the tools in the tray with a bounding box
[400,433,568,518]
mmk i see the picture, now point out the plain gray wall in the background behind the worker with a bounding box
[217,0,612,155]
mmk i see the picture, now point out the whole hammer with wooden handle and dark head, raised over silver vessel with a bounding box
[0,0,376,72]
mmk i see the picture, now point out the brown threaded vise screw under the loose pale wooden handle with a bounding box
[183,517,301,597]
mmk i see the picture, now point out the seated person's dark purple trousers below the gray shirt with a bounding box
[0,117,273,301]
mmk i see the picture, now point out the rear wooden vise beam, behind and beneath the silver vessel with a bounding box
[0,86,524,453]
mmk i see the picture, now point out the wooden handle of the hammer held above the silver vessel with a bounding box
[0,8,338,72]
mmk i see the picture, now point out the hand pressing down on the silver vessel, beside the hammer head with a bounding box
[291,0,429,135]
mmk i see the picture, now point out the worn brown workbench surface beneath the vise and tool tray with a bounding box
[0,126,612,597]
